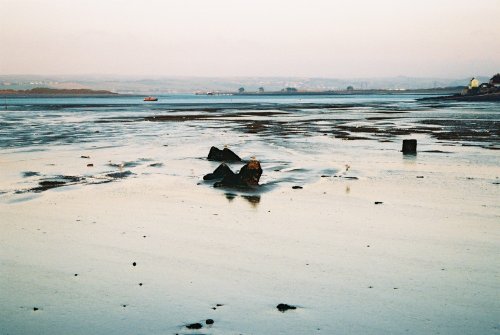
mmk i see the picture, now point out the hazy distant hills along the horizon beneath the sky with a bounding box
[0,75,489,95]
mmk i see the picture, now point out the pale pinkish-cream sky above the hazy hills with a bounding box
[0,0,500,78]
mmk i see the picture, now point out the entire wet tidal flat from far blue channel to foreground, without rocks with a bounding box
[0,95,500,334]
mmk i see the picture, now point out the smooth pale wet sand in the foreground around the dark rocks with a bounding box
[0,139,500,334]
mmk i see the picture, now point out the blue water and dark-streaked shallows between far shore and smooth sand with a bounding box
[0,94,500,149]
